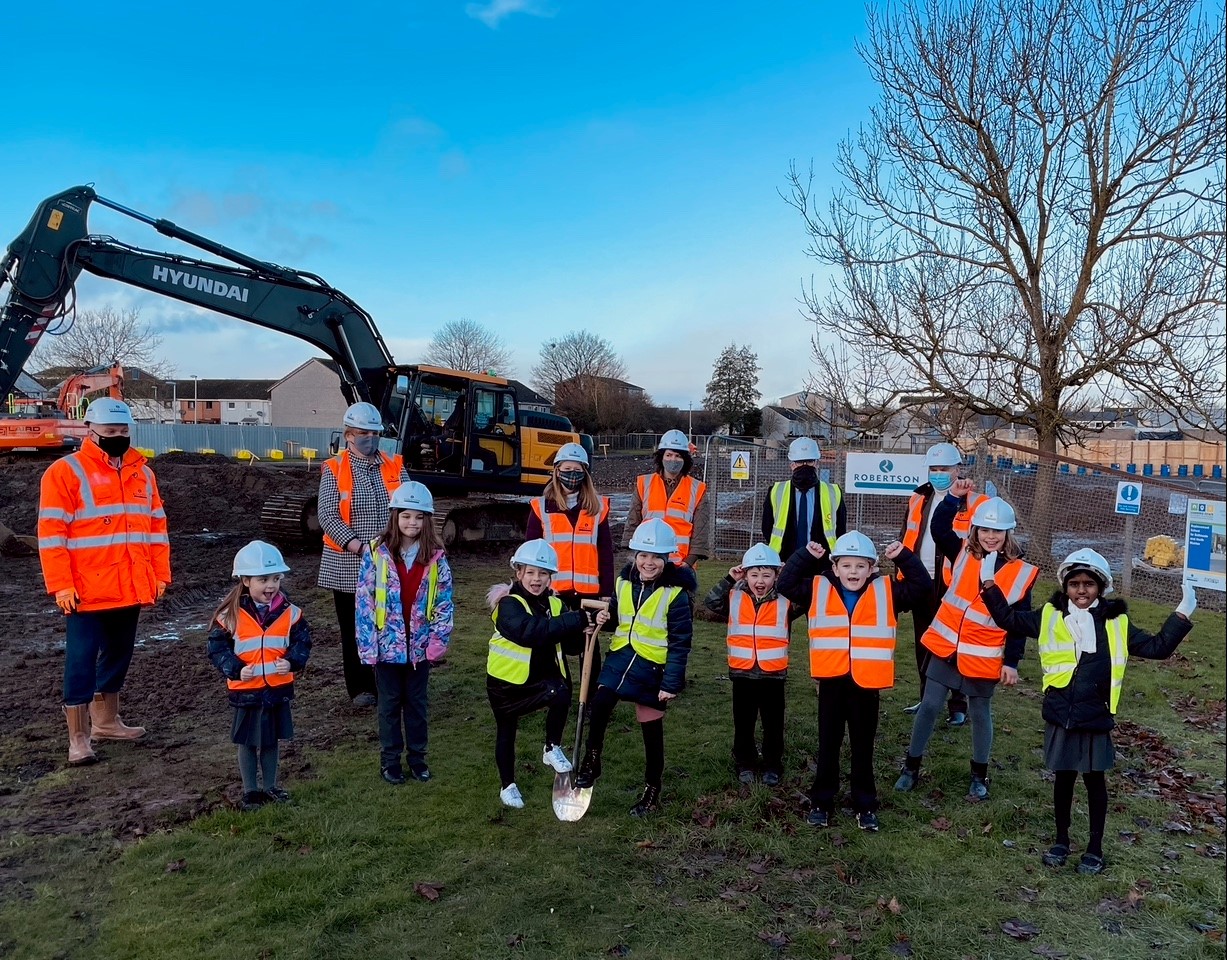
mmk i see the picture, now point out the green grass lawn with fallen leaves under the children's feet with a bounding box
[0,560,1225,960]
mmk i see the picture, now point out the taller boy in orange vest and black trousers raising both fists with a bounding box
[779,530,933,831]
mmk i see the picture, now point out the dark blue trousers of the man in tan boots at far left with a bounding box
[64,606,141,707]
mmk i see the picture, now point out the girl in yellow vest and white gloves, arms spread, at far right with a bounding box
[983,548,1198,874]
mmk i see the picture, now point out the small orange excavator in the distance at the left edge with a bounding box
[0,363,124,453]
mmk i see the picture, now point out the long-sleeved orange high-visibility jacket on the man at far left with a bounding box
[38,439,171,611]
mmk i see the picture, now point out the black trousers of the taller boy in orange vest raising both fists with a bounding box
[810,676,879,813]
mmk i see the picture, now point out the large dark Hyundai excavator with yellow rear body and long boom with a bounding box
[0,185,590,544]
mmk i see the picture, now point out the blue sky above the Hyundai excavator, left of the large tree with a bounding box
[0,0,874,408]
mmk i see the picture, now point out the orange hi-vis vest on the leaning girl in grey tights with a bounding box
[920,546,1039,680]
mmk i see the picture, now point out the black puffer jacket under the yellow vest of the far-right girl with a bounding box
[983,584,1193,733]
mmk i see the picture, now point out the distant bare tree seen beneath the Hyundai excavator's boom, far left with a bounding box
[38,304,173,378]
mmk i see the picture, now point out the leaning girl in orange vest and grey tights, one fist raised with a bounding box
[894,493,1039,800]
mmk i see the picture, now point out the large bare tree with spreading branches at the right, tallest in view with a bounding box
[785,0,1227,557]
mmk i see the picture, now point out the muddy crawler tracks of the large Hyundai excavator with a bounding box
[260,495,529,550]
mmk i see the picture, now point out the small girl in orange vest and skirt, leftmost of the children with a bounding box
[207,540,310,810]
